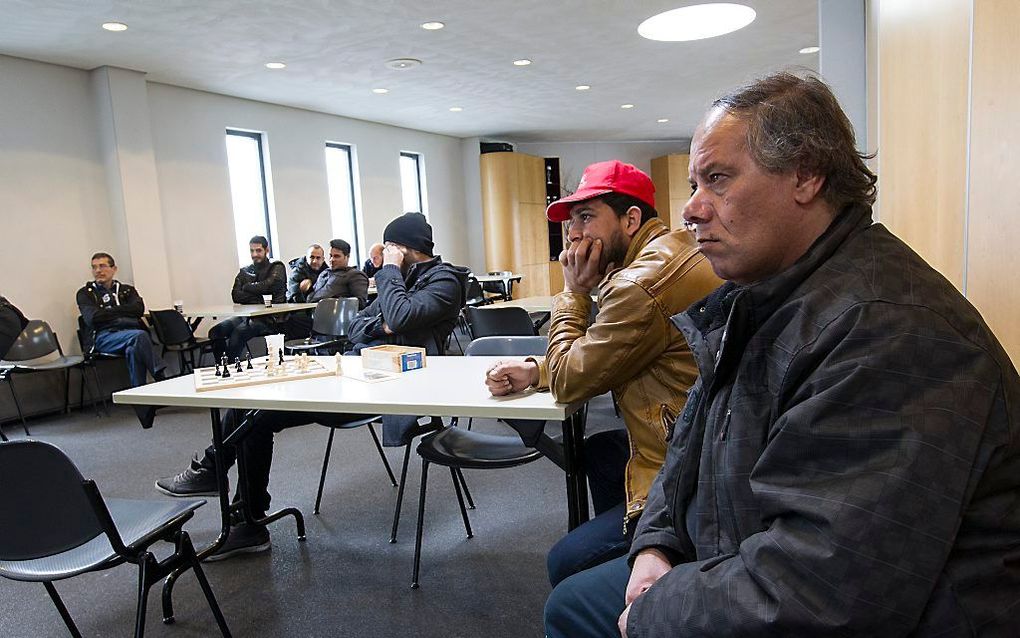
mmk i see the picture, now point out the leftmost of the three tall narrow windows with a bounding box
[226,129,276,266]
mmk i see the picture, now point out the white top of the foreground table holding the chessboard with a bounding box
[113,356,582,421]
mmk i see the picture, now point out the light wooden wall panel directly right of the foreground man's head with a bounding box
[874,0,971,288]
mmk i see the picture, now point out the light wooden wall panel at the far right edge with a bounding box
[967,0,1020,364]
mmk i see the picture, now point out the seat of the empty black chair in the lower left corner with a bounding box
[0,498,206,582]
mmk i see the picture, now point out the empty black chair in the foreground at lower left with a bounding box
[0,441,231,637]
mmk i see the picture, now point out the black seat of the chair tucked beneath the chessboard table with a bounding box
[417,428,542,470]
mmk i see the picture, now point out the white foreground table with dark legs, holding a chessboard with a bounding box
[113,356,589,556]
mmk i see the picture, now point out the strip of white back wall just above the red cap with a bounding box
[514,140,691,192]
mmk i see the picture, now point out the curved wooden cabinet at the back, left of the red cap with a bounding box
[479,152,563,297]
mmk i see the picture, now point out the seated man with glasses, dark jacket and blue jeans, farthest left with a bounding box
[74,252,166,387]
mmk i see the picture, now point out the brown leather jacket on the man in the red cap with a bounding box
[533,219,721,521]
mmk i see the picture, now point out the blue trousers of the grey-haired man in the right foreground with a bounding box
[545,556,630,638]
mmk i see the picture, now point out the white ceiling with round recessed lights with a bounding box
[0,0,818,141]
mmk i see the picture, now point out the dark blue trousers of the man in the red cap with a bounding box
[546,430,634,587]
